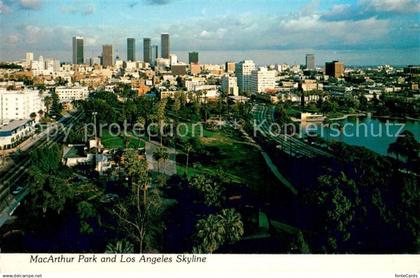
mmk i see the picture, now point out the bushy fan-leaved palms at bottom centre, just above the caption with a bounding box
[193,209,244,253]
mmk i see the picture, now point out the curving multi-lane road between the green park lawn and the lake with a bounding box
[252,104,332,158]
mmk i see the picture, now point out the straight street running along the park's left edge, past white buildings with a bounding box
[0,112,83,227]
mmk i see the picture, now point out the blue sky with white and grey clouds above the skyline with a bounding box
[0,0,420,65]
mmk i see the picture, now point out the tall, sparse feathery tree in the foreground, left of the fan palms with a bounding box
[112,149,162,253]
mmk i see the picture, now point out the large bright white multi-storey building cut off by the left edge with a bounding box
[0,88,44,122]
